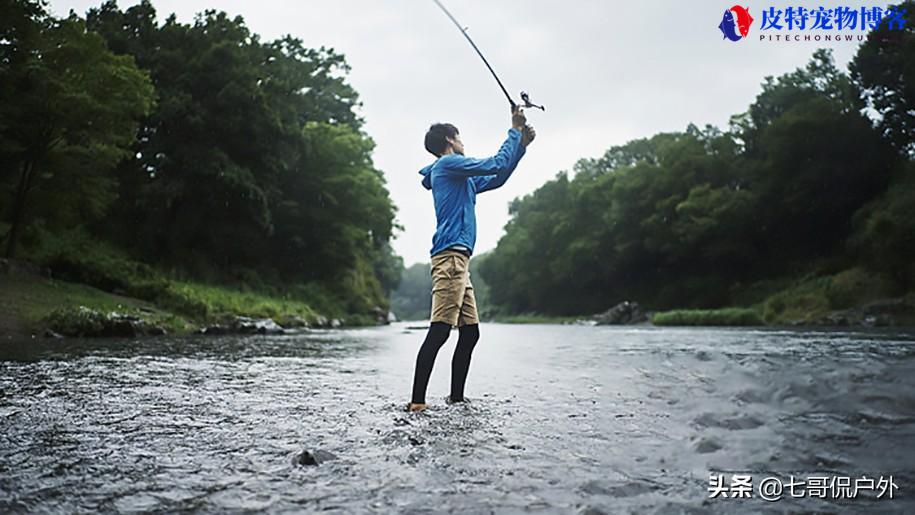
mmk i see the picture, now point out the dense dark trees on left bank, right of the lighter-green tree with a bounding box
[87,1,402,310]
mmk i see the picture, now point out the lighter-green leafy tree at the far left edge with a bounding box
[0,2,154,257]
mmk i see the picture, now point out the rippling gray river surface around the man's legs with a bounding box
[0,322,915,514]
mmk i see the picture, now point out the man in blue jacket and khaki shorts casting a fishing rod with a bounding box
[407,107,536,411]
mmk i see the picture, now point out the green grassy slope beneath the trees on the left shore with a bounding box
[0,230,376,336]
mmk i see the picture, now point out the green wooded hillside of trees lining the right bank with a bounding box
[480,1,915,315]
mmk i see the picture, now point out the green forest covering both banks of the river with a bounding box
[7,0,915,326]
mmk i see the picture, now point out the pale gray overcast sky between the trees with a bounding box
[50,0,883,266]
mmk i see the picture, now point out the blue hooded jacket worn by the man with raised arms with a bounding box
[419,128,526,255]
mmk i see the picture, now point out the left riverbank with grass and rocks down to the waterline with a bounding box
[0,260,386,340]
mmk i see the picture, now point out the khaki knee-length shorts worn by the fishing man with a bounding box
[429,249,480,327]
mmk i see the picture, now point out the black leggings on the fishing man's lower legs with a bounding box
[412,322,480,404]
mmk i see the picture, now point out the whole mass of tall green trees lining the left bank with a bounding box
[0,0,402,309]
